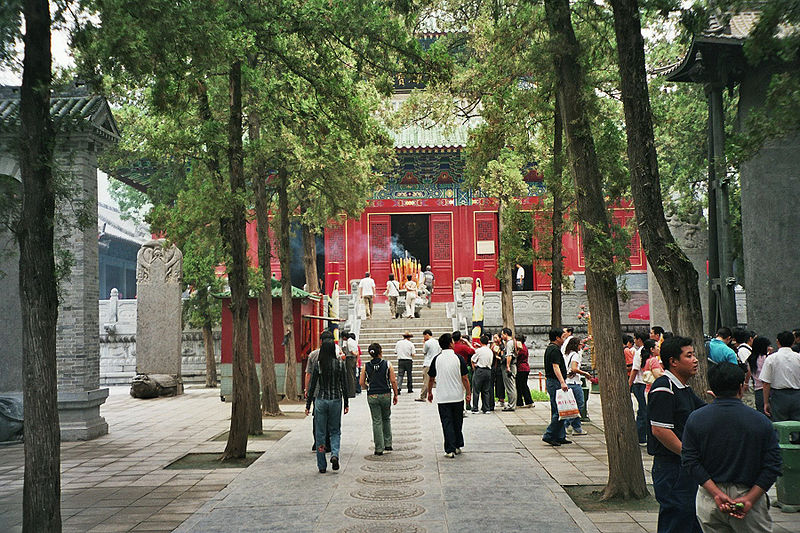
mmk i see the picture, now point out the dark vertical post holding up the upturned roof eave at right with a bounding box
[711,85,738,328]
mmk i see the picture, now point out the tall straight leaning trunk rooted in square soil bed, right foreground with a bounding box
[545,0,647,499]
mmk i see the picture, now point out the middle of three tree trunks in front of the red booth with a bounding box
[248,90,283,416]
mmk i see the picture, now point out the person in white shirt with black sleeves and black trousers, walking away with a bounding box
[428,333,470,458]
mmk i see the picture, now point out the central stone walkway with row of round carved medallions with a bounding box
[177,394,596,532]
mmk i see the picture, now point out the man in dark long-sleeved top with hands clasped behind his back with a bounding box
[681,363,781,532]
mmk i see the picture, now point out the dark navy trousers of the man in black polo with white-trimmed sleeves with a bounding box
[652,456,702,533]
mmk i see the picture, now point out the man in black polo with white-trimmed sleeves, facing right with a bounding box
[647,337,705,533]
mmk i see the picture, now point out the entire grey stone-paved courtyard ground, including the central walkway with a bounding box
[0,378,800,533]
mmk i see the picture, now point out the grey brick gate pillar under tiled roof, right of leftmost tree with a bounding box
[56,143,108,441]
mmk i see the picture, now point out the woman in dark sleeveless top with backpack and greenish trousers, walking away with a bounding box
[360,342,397,455]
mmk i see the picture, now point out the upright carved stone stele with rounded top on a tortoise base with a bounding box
[136,239,183,393]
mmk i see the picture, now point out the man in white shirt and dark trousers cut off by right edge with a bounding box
[758,331,800,422]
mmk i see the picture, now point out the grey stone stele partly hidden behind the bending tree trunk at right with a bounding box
[647,217,708,331]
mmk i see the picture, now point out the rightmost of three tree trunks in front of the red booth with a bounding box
[278,170,300,400]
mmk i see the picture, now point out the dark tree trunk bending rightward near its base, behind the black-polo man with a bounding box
[611,0,708,393]
